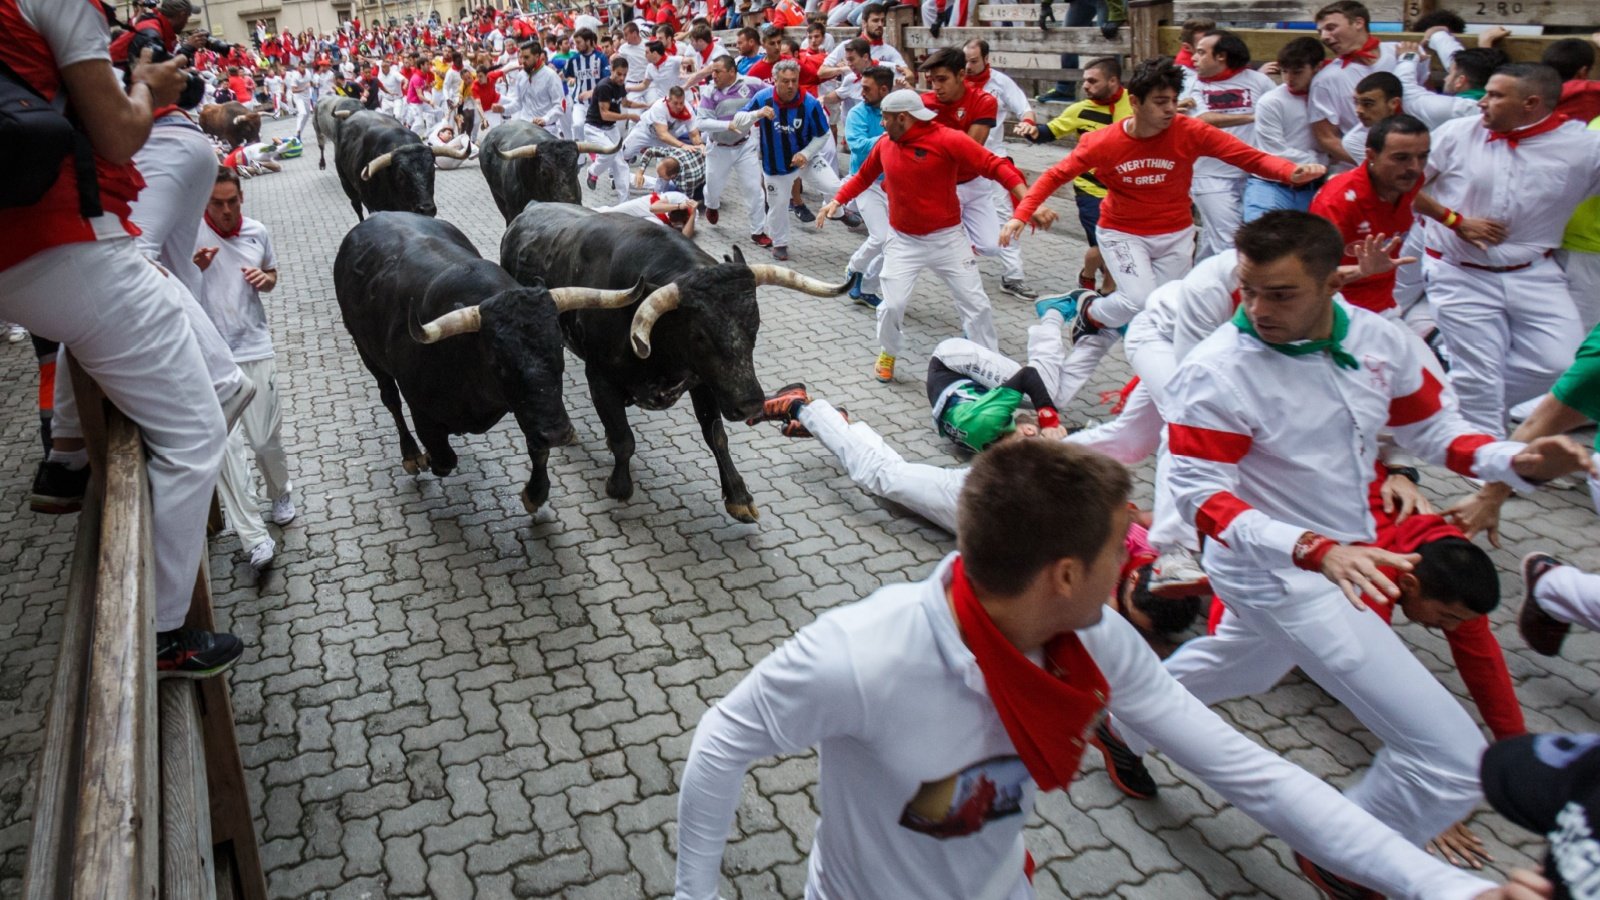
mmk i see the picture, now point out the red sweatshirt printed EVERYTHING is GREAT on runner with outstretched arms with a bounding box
[1016,115,1294,234]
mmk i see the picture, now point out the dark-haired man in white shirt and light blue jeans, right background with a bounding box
[1243,37,1328,223]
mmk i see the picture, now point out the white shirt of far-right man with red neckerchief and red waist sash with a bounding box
[1426,117,1600,266]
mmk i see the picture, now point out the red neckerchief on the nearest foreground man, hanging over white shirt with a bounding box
[950,557,1110,791]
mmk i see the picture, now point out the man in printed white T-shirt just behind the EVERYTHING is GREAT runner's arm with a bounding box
[1179,30,1273,259]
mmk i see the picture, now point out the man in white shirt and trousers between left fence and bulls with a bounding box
[194,168,294,572]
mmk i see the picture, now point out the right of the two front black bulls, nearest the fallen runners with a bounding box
[501,203,848,522]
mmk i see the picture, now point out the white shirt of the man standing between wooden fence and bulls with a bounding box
[195,216,278,362]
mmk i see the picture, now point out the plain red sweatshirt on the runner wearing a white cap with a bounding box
[834,122,1026,235]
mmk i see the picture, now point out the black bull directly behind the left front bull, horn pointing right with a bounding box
[333,109,466,219]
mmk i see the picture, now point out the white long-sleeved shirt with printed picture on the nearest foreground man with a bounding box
[677,554,1490,900]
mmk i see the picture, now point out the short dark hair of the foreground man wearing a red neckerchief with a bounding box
[955,438,1132,597]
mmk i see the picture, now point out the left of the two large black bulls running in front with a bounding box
[333,213,643,520]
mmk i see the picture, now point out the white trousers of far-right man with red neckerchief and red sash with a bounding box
[1424,256,1586,437]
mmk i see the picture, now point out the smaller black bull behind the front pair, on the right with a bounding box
[478,120,618,223]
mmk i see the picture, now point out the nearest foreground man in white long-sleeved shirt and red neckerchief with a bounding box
[677,440,1536,900]
